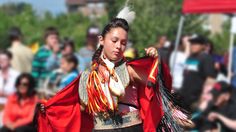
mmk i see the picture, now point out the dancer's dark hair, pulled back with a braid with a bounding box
[92,18,129,62]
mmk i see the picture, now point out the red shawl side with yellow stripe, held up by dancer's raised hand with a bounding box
[128,57,172,132]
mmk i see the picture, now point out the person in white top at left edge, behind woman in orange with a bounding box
[0,51,19,107]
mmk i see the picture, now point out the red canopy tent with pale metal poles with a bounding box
[172,0,236,81]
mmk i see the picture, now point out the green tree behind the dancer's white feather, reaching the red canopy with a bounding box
[108,0,207,53]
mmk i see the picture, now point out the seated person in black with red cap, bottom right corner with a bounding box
[193,82,236,132]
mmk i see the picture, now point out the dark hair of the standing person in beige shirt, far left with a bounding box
[8,27,22,42]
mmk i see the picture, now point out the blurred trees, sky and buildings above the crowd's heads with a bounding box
[0,0,229,53]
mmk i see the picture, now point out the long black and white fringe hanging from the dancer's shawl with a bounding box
[156,60,192,132]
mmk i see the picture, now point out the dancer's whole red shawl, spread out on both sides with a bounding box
[37,57,171,132]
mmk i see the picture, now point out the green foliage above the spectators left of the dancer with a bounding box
[0,3,91,48]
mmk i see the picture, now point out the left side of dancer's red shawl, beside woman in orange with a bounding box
[37,77,93,132]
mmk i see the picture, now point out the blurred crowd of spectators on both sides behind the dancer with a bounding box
[0,26,236,132]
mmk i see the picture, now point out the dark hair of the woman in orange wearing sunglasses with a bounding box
[15,73,36,99]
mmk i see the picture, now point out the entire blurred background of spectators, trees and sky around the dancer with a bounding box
[0,0,236,131]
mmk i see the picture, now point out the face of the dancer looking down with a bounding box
[99,27,128,62]
